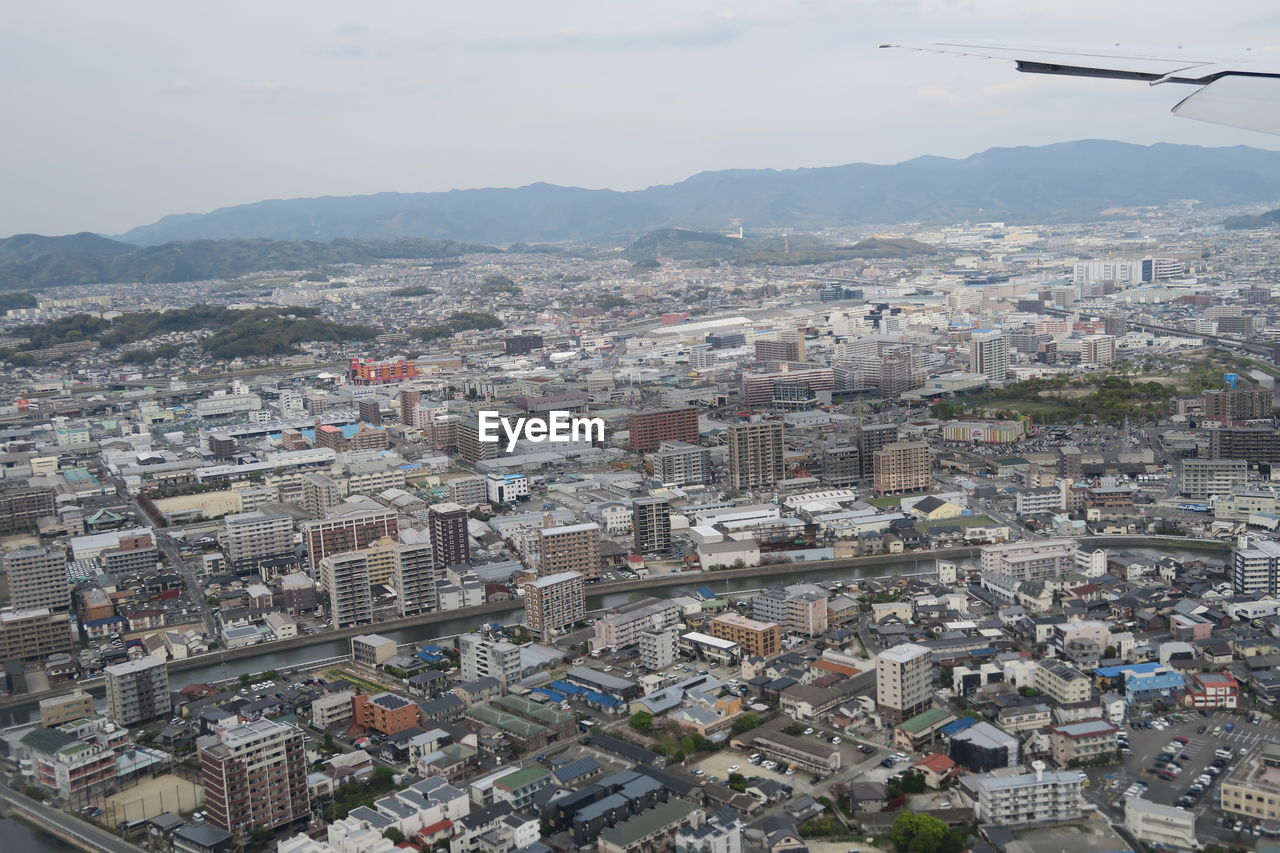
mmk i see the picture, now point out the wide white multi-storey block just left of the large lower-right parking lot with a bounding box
[960,761,1084,826]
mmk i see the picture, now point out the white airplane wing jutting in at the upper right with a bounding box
[881,42,1280,136]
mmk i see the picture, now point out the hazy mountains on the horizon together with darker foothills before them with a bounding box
[0,140,1280,291]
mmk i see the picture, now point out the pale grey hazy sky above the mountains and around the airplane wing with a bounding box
[0,0,1280,234]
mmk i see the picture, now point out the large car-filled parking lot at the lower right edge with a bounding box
[1087,711,1280,839]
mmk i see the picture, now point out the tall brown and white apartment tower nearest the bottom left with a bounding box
[196,720,311,838]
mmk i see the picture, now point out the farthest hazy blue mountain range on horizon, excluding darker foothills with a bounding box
[112,140,1280,246]
